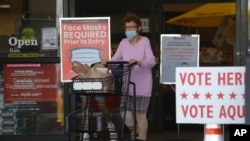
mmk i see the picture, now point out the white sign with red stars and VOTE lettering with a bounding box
[176,67,246,124]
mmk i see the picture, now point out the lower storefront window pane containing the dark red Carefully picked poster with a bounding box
[0,64,64,135]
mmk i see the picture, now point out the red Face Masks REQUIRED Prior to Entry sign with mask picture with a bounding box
[60,17,110,82]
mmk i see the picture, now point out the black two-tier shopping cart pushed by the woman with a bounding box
[65,61,135,141]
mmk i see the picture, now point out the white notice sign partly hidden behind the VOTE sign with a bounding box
[160,34,199,84]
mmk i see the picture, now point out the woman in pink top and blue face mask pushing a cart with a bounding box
[105,13,156,141]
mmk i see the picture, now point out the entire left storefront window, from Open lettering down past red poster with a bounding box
[0,0,64,136]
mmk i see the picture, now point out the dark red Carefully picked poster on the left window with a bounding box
[4,64,59,102]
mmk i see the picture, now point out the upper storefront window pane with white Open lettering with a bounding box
[0,0,58,58]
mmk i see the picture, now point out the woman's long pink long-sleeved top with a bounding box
[111,36,156,96]
